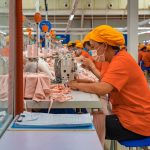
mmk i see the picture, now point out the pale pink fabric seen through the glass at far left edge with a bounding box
[0,75,8,101]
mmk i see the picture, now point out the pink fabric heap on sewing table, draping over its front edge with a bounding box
[24,73,72,102]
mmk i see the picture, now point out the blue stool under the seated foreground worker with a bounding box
[111,137,150,150]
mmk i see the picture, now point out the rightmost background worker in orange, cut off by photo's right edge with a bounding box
[142,45,150,67]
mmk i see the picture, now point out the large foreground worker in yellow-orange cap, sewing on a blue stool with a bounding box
[68,25,150,143]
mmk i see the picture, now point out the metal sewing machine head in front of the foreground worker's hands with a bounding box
[54,53,77,83]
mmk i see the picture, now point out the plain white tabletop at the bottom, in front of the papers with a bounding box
[0,131,103,150]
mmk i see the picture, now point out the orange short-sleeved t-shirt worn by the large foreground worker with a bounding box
[102,50,150,136]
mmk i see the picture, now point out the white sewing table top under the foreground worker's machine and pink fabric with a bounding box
[26,91,102,109]
